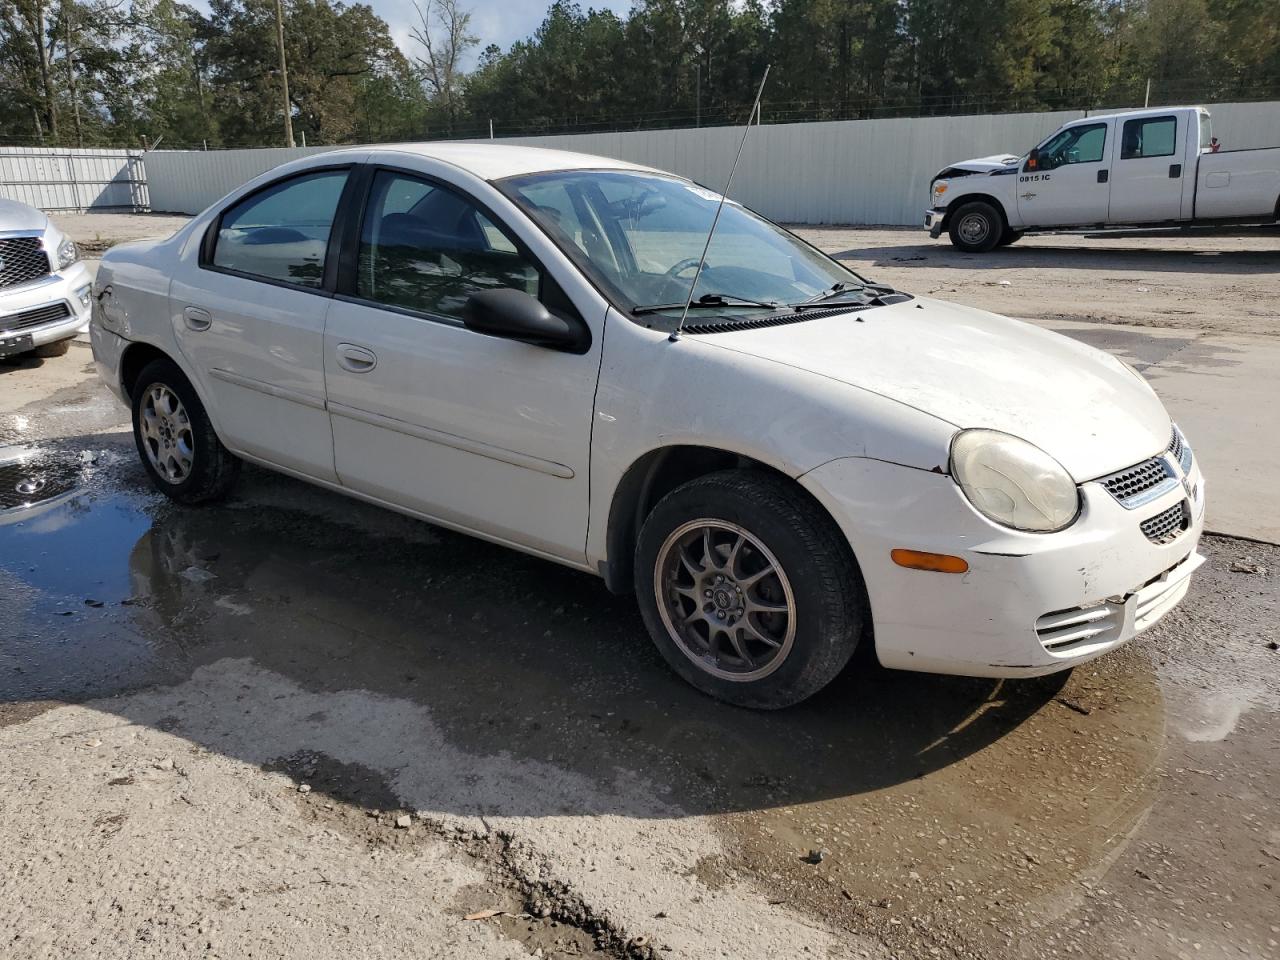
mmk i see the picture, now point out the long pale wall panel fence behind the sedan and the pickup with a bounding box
[129,102,1280,224]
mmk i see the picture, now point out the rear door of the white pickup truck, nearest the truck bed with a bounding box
[1107,114,1194,223]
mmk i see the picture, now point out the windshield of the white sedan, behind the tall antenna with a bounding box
[503,170,873,325]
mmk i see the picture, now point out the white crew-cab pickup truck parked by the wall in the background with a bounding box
[924,106,1280,253]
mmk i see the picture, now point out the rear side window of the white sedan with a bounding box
[212,170,347,287]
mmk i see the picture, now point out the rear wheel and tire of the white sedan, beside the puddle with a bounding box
[131,360,241,504]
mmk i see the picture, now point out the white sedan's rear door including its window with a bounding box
[169,165,351,483]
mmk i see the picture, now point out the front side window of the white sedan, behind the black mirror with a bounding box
[356,170,540,319]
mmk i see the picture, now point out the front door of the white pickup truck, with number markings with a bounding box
[1018,120,1110,228]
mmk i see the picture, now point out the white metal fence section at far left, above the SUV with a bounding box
[0,147,151,214]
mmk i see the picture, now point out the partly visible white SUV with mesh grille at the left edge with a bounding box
[0,200,93,357]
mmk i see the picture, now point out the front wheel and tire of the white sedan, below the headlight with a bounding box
[635,470,869,709]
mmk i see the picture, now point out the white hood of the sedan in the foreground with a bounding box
[700,298,1172,483]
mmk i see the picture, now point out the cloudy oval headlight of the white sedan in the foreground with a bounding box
[951,430,1080,534]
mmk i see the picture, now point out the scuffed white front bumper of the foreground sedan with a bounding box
[801,458,1204,677]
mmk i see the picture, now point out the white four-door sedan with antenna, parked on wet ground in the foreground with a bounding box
[92,143,1204,708]
